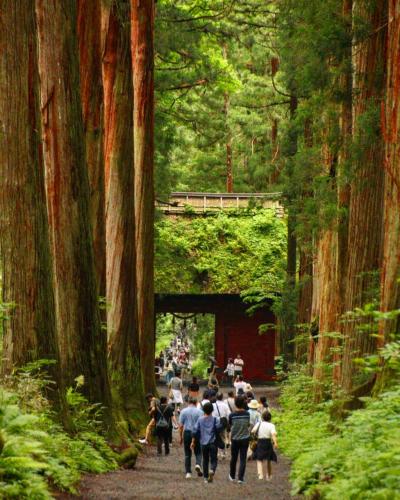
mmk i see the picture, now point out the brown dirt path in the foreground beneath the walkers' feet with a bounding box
[63,387,293,500]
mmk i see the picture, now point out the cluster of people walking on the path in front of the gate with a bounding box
[140,355,278,484]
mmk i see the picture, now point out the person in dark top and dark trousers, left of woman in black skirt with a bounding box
[229,396,250,484]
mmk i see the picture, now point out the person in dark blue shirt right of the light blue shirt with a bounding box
[190,403,221,483]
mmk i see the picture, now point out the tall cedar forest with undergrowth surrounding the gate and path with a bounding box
[0,0,400,499]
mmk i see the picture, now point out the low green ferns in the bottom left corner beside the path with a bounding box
[0,388,116,500]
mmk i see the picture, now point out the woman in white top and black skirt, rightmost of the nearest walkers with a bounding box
[252,411,278,481]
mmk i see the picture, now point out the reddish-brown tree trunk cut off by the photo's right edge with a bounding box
[378,0,400,384]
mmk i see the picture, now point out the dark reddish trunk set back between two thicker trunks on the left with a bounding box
[78,0,106,297]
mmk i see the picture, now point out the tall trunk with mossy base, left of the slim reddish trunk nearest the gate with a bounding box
[102,1,143,418]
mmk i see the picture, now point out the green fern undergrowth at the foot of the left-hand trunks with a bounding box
[0,373,117,500]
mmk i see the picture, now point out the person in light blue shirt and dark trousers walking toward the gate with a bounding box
[179,398,203,479]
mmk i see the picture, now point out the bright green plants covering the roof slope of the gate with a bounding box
[155,210,286,295]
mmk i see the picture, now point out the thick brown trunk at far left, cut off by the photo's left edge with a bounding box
[0,0,60,384]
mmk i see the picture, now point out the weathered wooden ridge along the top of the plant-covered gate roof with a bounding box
[156,192,284,217]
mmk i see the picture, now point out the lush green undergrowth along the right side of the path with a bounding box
[276,372,400,500]
